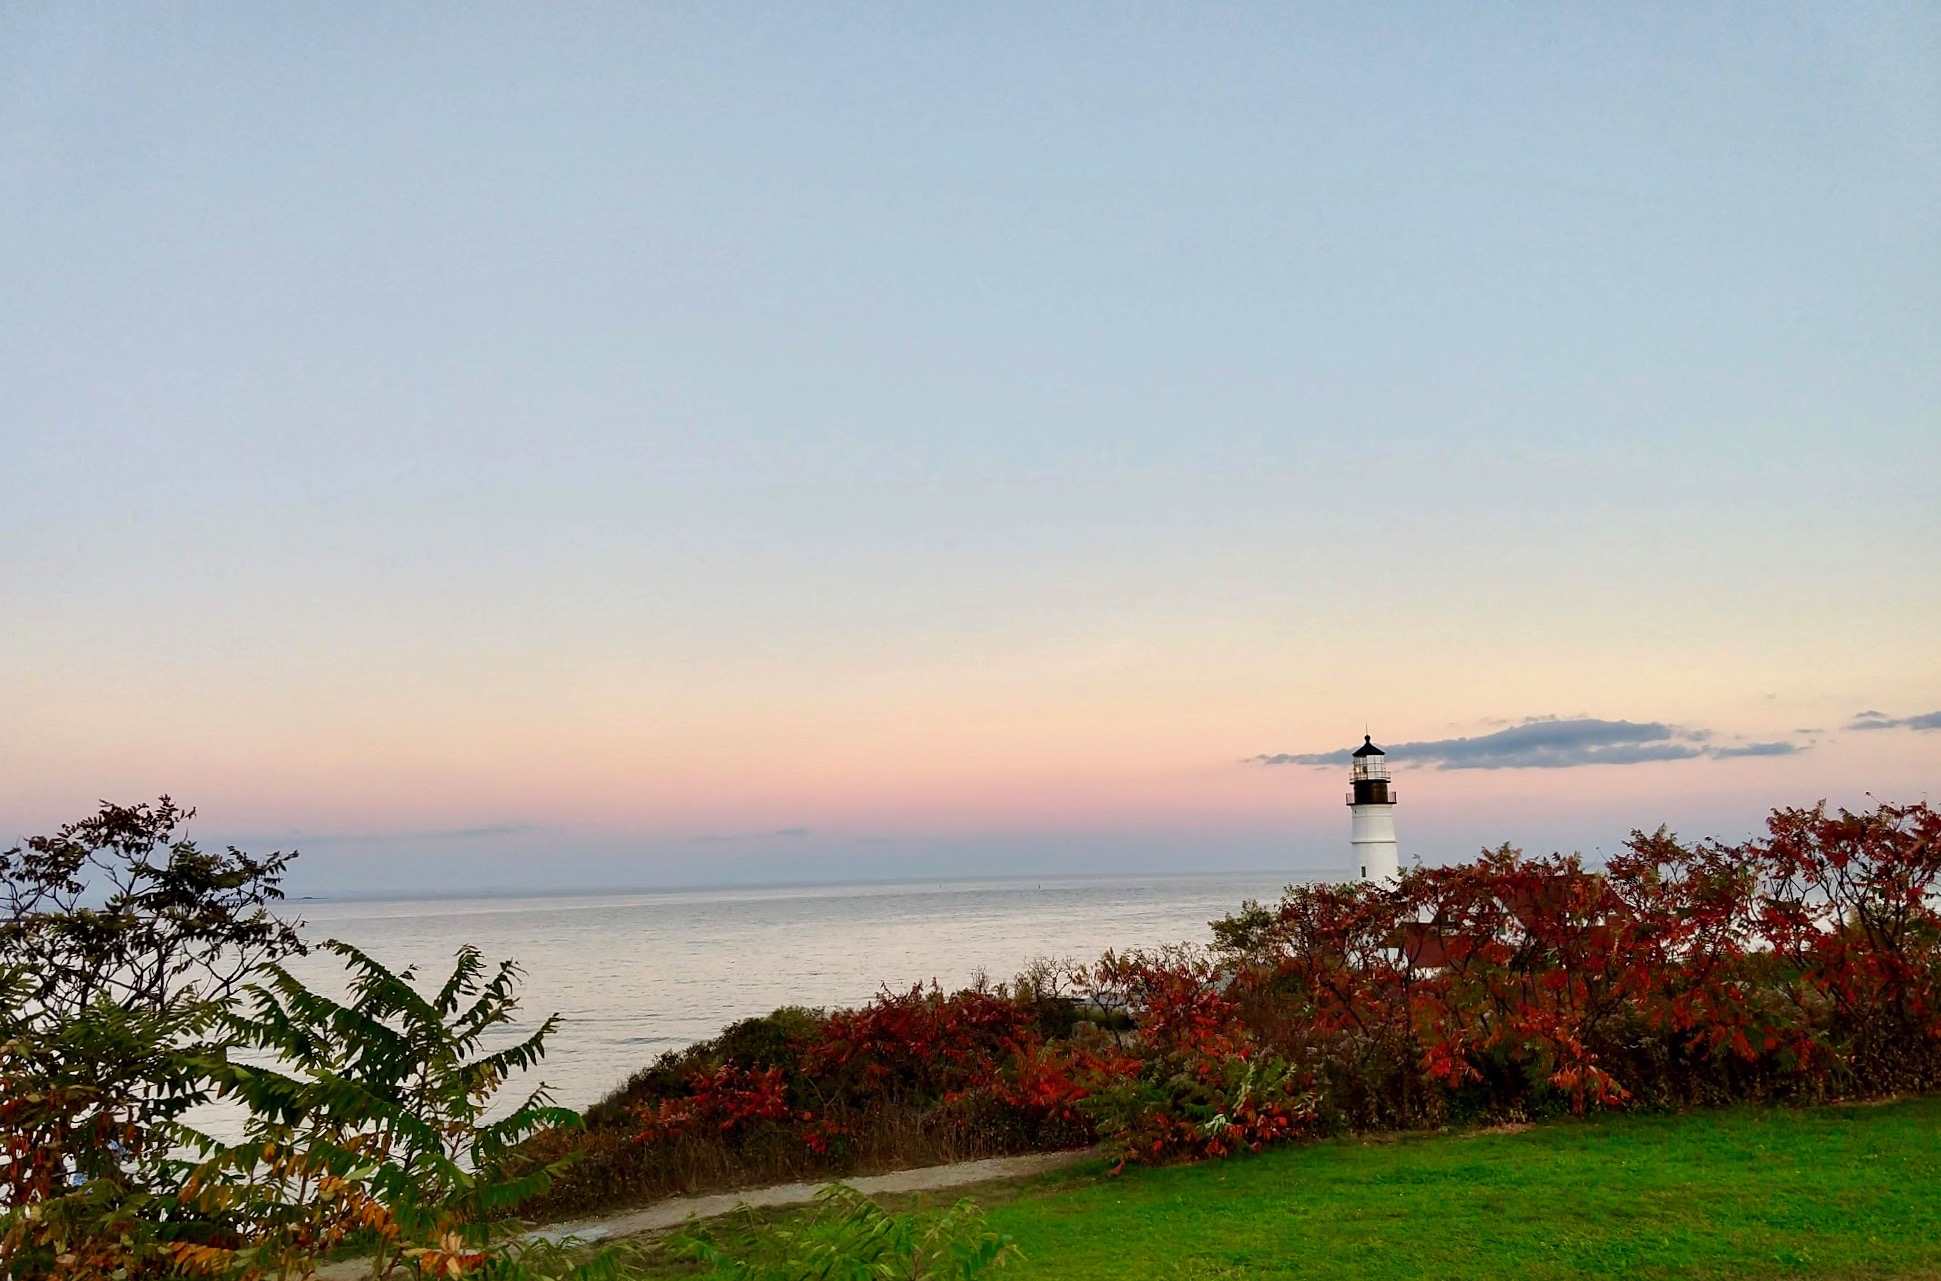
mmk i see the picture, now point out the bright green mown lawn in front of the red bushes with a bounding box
[990,1099,1941,1281]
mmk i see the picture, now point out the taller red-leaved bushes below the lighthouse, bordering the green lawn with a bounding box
[1223,805,1941,1124]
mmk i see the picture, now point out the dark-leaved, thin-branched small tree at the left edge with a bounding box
[0,798,301,1277]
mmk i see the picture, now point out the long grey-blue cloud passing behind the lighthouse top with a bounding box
[1252,716,1803,769]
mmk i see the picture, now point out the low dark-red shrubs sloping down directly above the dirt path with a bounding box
[534,982,1093,1215]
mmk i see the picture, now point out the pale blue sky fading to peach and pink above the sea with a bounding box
[0,4,1941,893]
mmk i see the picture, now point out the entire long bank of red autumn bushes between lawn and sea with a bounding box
[635,805,1941,1163]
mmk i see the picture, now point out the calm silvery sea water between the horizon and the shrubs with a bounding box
[277,873,1289,1106]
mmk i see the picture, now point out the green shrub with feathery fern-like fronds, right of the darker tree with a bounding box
[186,941,580,1277]
